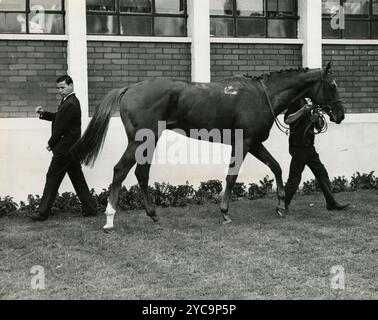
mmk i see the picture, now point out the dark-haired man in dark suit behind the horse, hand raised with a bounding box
[30,75,97,221]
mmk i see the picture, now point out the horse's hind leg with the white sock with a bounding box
[104,141,138,231]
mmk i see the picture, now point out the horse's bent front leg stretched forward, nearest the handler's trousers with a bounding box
[249,143,286,217]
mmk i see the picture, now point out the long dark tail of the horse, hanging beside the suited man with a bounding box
[71,87,128,166]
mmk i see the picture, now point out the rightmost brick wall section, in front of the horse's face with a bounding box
[323,45,378,113]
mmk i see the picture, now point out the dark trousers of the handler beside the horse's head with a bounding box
[285,146,336,207]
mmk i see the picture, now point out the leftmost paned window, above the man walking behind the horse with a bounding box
[0,0,64,34]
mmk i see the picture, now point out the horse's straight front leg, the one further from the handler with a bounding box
[220,139,249,224]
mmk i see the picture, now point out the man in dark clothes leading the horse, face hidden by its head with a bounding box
[284,99,349,211]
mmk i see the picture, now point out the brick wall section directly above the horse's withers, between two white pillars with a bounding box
[211,43,302,81]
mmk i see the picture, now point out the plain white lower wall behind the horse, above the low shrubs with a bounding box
[0,114,378,201]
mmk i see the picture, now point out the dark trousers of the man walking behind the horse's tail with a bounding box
[38,155,96,216]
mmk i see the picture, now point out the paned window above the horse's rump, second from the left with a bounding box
[86,0,187,37]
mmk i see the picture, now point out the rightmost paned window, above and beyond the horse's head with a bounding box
[322,0,378,39]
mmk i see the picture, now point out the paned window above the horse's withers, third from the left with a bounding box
[210,0,298,38]
